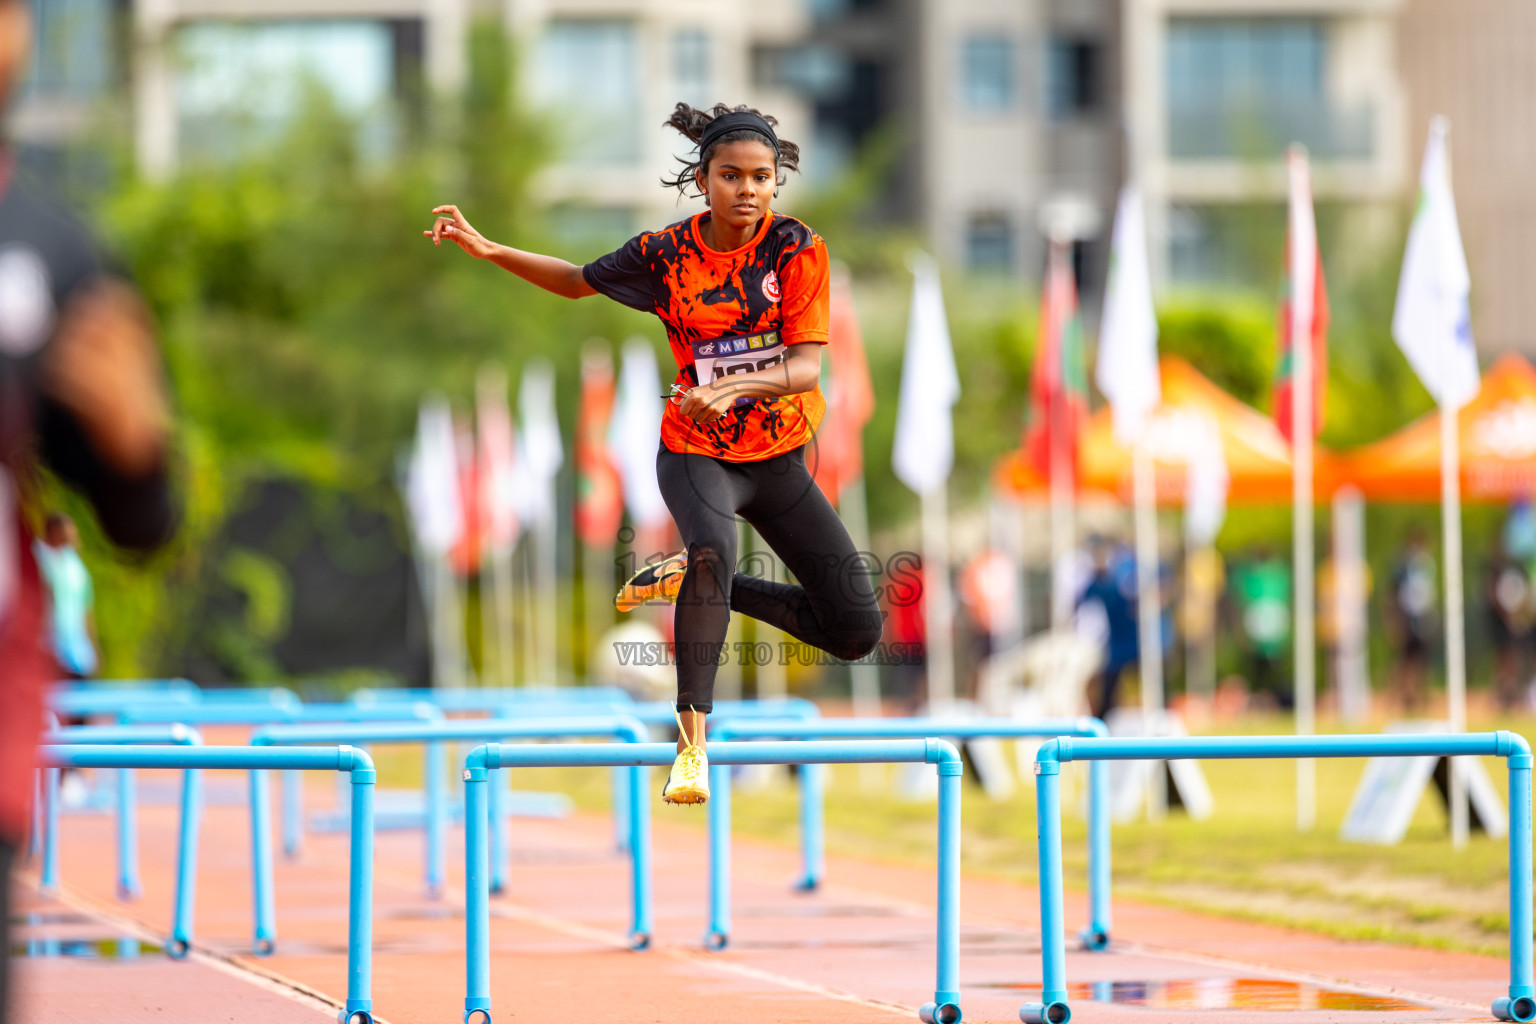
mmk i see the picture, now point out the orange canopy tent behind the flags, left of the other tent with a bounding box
[992,356,1341,505]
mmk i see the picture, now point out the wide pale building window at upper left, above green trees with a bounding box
[175,20,395,158]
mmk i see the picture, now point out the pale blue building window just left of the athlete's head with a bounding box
[535,20,641,164]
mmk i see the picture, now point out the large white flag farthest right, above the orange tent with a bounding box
[1392,117,1481,408]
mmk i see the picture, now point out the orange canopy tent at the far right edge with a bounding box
[1339,353,1536,502]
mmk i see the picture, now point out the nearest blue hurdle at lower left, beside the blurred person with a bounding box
[38,745,376,1024]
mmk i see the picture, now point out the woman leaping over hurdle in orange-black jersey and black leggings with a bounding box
[422,103,880,803]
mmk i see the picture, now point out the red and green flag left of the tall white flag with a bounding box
[1025,244,1087,481]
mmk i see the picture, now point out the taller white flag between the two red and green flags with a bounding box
[1094,186,1163,447]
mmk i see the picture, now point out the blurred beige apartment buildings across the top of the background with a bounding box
[21,0,1536,353]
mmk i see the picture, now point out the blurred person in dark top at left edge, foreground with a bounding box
[0,0,174,1019]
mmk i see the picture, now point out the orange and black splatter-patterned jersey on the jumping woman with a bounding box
[582,212,831,462]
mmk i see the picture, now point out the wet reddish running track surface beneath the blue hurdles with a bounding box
[14,772,1507,1024]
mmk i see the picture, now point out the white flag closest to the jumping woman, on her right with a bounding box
[891,255,960,494]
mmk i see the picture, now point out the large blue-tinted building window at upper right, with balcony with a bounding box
[1164,17,1373,158]
